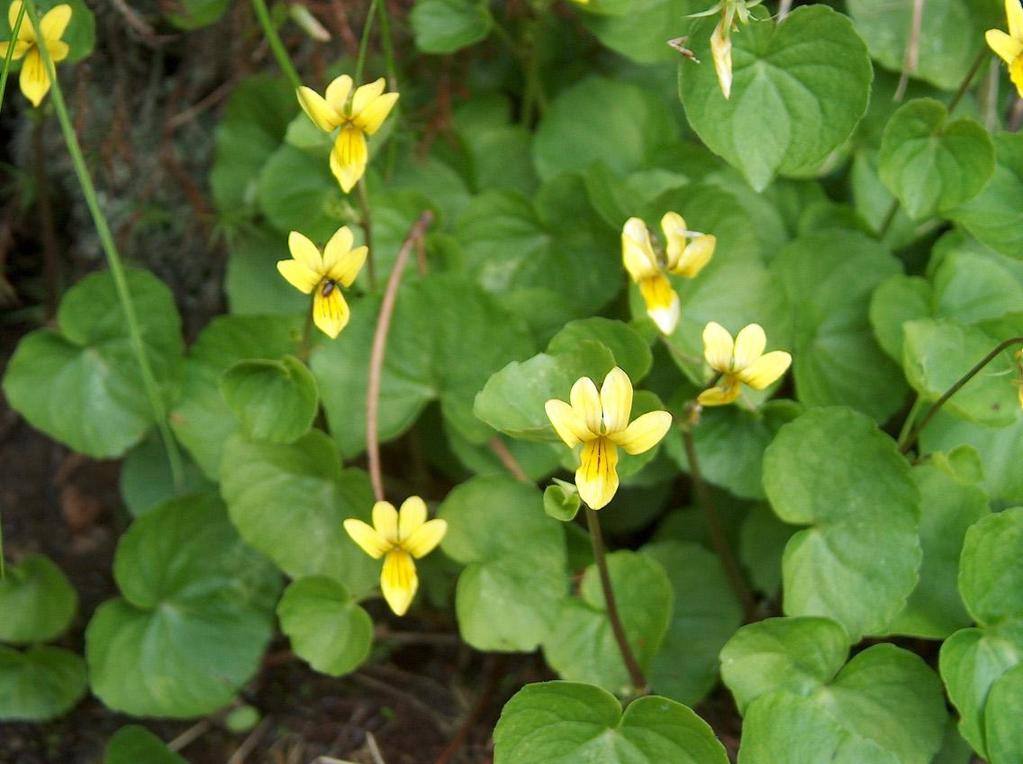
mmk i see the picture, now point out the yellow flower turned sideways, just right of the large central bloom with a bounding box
[697,321,792,406]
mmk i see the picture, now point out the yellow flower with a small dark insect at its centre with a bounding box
[277,226,368,339]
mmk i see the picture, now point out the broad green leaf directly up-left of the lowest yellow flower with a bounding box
[220,430,380,597]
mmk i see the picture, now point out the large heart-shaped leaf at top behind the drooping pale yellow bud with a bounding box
[678,5,873,191]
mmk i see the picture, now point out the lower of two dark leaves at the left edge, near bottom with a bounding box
[0,645,88,722]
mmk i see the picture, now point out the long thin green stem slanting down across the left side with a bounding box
[24,0,183,486]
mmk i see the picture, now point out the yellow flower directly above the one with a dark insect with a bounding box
[298,75,398,193]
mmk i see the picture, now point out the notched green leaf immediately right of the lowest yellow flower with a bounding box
[437,478,568,653]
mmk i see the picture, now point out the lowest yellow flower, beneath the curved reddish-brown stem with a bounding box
[345,496,447,616]
